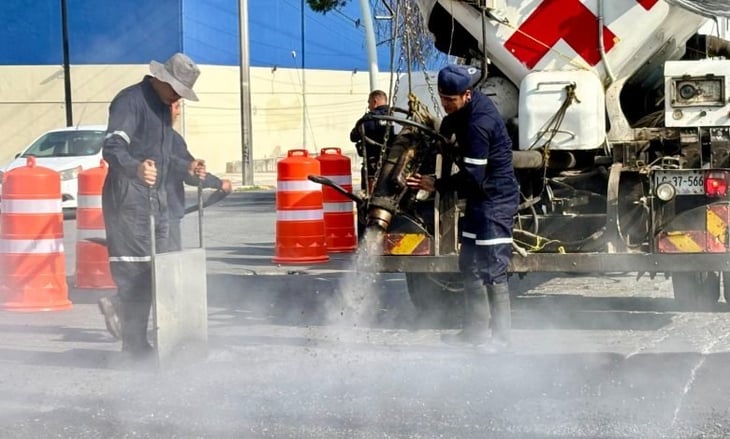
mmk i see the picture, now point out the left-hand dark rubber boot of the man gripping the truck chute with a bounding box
[441,281,489,345]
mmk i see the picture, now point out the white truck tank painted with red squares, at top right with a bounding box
[417,0,707,84]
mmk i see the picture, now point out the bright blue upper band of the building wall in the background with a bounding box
[0,0,389,70]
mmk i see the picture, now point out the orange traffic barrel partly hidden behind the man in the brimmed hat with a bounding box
[74,160,116,289]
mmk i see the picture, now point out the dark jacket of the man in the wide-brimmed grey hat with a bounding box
[102,76,187,217]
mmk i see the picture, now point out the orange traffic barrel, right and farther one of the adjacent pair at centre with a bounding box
[317,148,357,253]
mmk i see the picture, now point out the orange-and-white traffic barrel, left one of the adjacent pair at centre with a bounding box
[273,149,329,264]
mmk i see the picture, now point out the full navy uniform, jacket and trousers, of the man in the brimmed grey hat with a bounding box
[102,76,187,338]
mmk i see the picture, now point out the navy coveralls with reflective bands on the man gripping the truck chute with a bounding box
[436,90,519,285]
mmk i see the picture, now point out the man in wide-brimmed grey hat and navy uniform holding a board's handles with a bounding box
[99,53,205,359]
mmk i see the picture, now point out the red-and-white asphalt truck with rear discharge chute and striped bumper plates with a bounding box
[316,0,730,311]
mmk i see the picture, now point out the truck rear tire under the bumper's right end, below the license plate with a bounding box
[672,271,720,311]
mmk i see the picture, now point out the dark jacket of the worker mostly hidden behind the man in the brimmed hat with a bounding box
[166,131,221,220]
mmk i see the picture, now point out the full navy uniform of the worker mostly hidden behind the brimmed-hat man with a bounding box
[165,131,222,251]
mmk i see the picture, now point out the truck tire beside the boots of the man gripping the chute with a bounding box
[406,273,464,327]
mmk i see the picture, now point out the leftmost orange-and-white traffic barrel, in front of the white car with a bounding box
[0,157,71,311]
